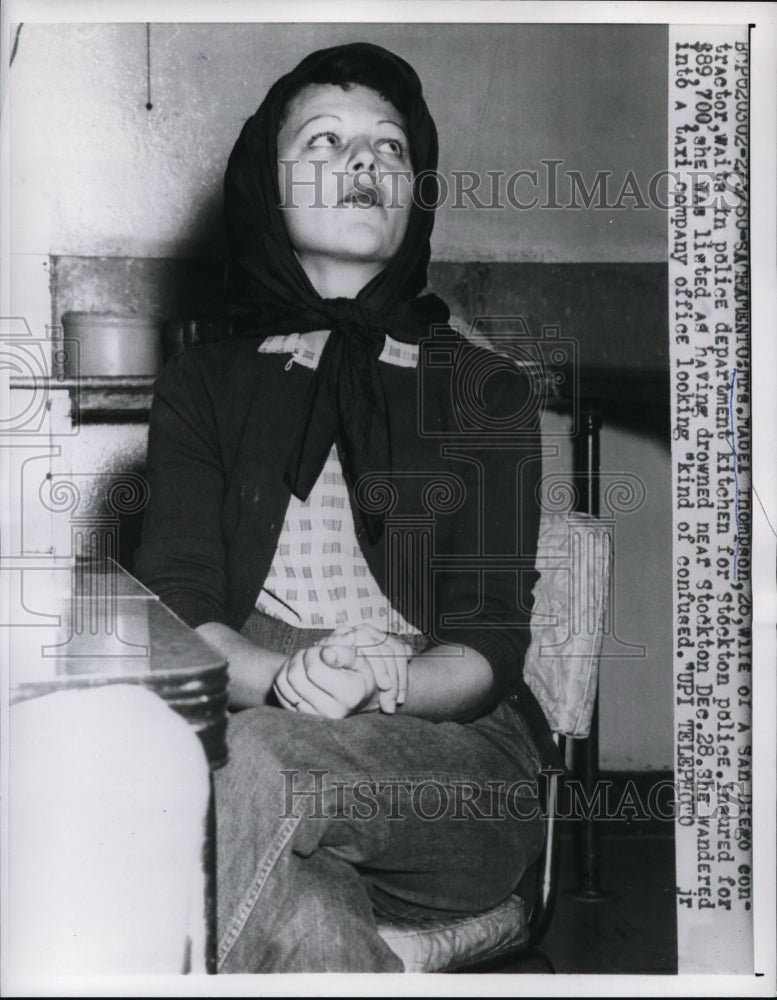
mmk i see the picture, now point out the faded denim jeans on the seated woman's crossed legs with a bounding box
[214,614,543,973]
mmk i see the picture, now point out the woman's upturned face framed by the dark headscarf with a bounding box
[278,84,412,266]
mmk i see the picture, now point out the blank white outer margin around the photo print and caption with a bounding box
[0,0,777,996]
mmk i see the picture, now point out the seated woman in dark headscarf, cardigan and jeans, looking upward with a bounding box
[137,43,547,972]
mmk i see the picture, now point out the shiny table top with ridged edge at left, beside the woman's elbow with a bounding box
[7,561,227,766]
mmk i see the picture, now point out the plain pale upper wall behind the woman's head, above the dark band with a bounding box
[11,24,666,261]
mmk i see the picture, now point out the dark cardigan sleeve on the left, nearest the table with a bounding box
[136,352,226,627]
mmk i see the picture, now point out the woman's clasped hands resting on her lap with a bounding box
[273,625,412,719]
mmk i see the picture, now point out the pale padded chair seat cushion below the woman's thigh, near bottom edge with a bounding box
[378,895,529,972]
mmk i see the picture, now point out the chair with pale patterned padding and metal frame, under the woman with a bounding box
[378,513,612,972]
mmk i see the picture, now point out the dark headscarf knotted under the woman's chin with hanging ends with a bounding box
[224,42,449,542]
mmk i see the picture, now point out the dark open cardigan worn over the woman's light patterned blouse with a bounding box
[136,331,546,735]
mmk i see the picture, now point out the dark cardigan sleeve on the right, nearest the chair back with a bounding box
[428,356,542,721]
